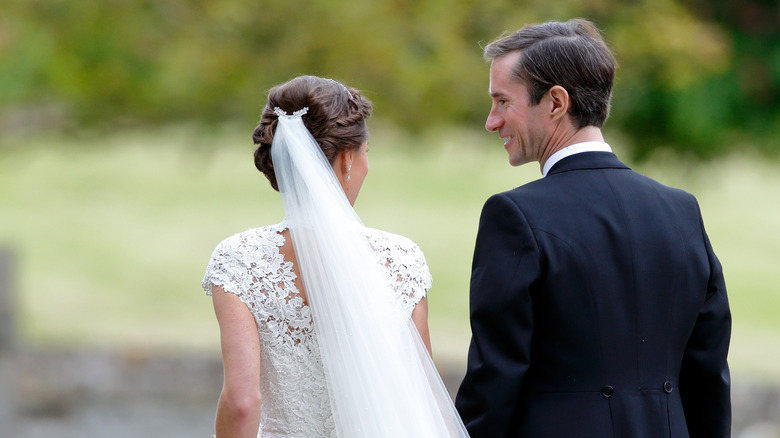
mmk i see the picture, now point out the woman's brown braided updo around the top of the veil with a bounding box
[252,76,372,191]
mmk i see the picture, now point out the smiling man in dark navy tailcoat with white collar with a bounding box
[455,19,731,438]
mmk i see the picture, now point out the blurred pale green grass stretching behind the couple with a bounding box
[0,127,780,381]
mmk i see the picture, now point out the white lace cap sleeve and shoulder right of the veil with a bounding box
[367,229,433,314]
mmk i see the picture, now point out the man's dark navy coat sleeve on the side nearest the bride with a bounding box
[455,194,540,438]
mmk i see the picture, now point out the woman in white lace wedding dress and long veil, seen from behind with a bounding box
[203,76,467,438]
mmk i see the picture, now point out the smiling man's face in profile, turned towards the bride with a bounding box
[485,51,546,166]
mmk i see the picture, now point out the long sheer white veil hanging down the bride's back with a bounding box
[271,108,468,438]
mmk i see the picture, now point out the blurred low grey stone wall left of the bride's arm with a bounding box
[0,349,222,438]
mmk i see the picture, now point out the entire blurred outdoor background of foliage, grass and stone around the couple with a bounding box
[0,0,780,438]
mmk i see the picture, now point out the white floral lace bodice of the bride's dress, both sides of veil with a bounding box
[202,222,431,438]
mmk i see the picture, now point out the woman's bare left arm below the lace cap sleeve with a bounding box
[212,286,260,438]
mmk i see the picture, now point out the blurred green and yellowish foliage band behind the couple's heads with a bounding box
[0,0,780,158]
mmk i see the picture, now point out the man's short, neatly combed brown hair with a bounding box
[484,18,617,129]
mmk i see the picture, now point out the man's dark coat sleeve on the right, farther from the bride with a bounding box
[680,202,731,438]
